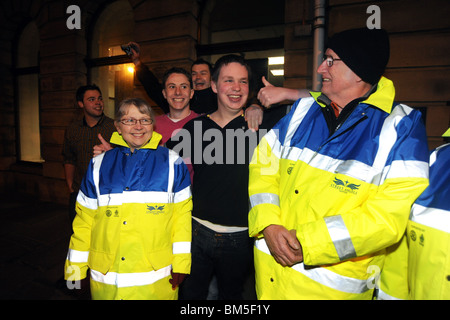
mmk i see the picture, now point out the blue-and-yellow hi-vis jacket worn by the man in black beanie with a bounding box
[249,77,429,299]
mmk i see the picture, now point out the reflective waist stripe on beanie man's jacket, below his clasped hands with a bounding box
[255,239,369,294]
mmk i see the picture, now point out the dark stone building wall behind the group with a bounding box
[0,0,450,203]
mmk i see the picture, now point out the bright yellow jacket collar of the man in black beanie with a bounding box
[311,77,395,113]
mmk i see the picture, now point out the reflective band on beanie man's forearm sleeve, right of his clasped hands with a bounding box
[324,216,356,261]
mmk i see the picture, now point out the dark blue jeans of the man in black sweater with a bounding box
[179,220,254,300]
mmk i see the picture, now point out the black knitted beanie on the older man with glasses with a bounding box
[328,28,389,85]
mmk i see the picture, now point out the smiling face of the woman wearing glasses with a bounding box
[115,104,153,152]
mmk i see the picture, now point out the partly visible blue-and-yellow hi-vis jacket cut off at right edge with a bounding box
[377,144,450,300]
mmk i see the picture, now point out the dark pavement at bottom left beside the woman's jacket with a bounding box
[0,194,90,300]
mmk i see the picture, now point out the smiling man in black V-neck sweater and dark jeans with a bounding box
[166,55,279,300]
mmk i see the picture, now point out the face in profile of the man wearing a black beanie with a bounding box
[317,49,361,107]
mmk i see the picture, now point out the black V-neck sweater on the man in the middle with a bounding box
[166,112,283,227]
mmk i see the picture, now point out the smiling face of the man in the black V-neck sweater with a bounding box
[211,62,249,111]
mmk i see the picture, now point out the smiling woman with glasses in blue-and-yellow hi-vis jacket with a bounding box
[65,99,192,299]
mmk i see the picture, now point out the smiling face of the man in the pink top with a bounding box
[163,73,194,110]
